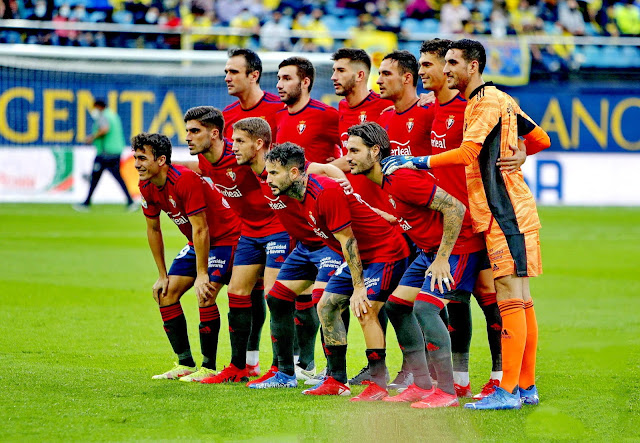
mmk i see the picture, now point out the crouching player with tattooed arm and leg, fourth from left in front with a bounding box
[265,143,409,401]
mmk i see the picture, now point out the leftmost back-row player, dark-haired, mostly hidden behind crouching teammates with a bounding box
[222,48,284,376]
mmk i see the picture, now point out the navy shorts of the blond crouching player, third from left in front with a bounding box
[233,232,293,269]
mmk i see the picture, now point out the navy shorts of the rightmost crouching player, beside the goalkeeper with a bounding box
[400,251,487,303]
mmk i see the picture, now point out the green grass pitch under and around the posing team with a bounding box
[0,204,640,442]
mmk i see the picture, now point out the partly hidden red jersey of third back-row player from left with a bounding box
[338,91,394,219]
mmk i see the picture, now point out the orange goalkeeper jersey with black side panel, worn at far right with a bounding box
[431,83,548,235]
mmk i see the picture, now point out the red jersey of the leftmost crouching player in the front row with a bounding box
[138,166,241,246]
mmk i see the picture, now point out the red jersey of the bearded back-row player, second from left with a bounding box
[275,99,340,163]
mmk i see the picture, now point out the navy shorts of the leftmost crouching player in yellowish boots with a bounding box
[169,245,236,285]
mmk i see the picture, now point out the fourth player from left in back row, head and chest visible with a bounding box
[377,51,433,156]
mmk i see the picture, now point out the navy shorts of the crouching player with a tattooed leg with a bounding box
[324,258,409,302]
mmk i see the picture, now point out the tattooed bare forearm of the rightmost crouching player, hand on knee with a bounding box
[426,188,466,292]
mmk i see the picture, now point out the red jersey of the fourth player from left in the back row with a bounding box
[379,102,434,157]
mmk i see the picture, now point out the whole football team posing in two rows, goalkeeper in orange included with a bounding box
[132,39,549,409]
